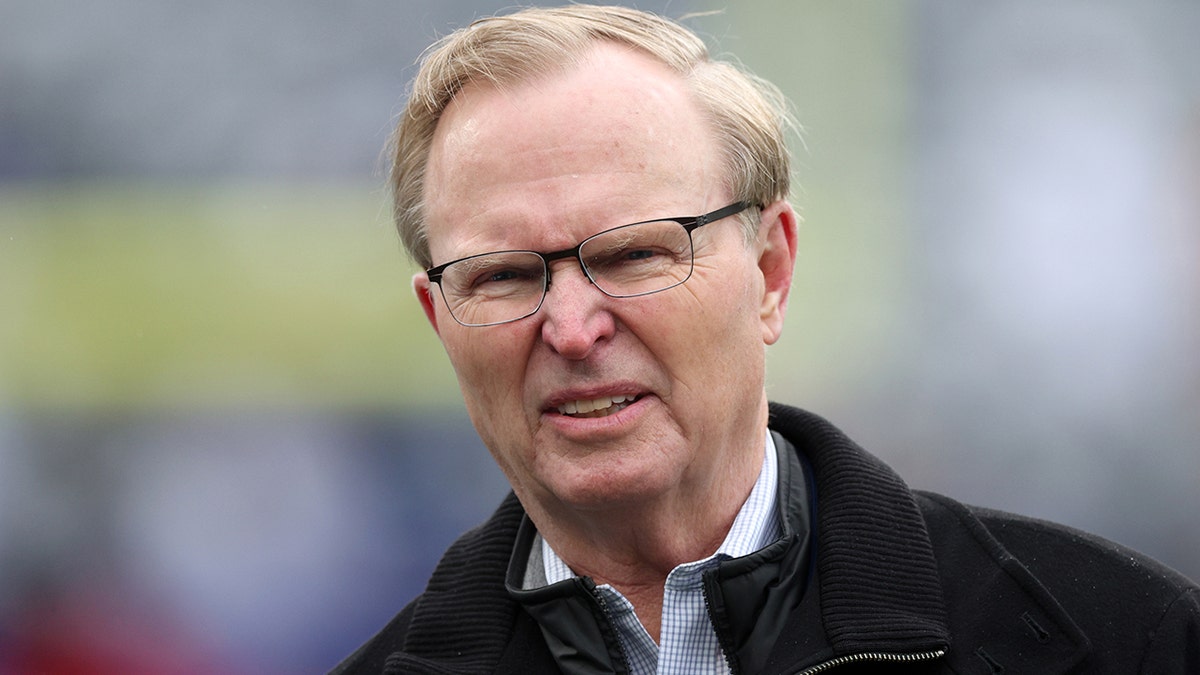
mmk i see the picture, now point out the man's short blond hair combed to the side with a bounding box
[389,5,791,268]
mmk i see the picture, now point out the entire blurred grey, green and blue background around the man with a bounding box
[0,0,1200,675]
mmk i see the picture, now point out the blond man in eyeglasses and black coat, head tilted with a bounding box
[337,5,1200,674]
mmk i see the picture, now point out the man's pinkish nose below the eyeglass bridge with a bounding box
[535,254,617,360]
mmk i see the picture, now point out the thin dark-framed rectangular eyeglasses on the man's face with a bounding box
[425,202,750,325]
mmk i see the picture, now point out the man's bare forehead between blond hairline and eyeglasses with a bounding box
[425,44,721,261]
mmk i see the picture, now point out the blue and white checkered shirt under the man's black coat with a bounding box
[541,431,782,675]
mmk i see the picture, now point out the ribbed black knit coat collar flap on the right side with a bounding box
[770,404,950,656]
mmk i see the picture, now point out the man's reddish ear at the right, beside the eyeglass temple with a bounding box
[758,199,798,345]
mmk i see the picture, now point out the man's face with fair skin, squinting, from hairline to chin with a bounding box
[414,46,794,513]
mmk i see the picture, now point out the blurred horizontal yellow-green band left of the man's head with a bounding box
[0,184,456,408]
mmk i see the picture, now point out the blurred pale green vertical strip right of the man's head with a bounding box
[708,0,916,410]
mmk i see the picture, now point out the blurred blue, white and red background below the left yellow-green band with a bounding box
[0,410,506,673]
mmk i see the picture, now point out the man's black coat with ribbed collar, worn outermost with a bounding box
[334,405,1200,675]
